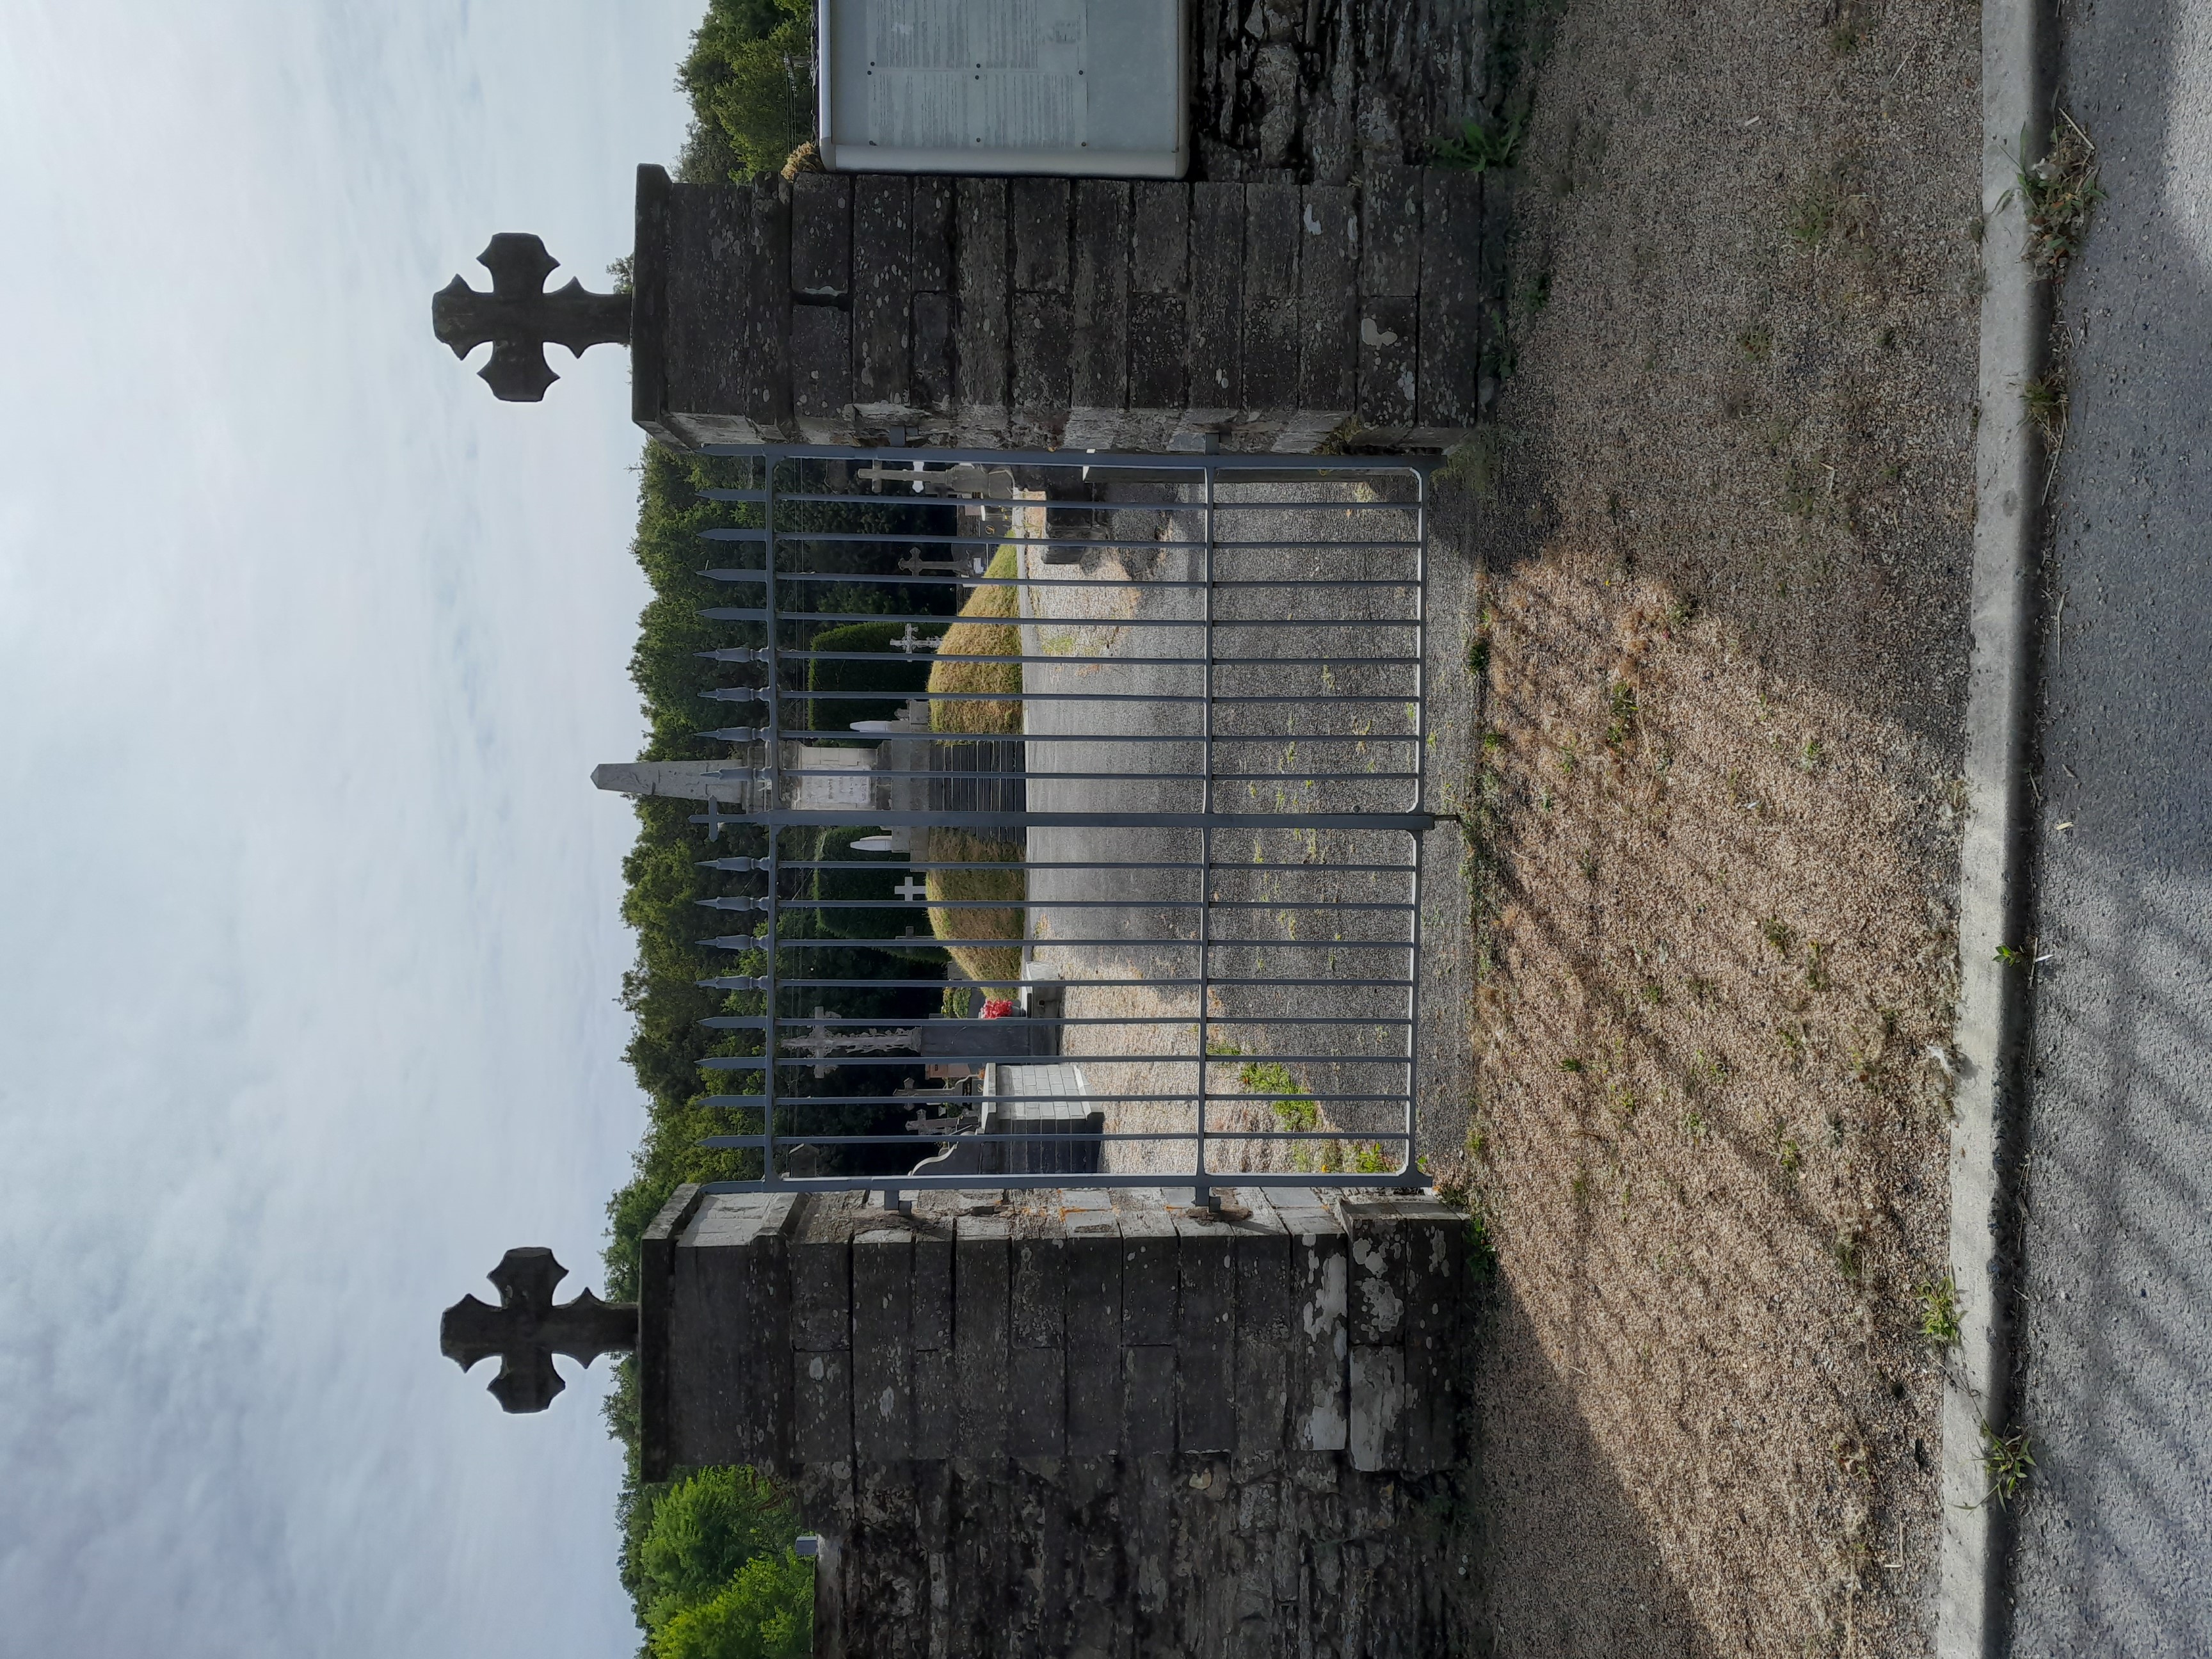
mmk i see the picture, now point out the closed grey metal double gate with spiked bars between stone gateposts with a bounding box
[659,435,1433,1201]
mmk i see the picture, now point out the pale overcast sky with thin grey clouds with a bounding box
[0,0,703,1659]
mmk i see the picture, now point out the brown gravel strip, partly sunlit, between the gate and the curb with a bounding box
[1455,0,1980,1657]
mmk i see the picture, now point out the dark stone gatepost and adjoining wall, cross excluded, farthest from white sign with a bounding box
[639,1188,1466,1659]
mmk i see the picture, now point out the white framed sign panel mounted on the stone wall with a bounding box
[816,0,1190,179]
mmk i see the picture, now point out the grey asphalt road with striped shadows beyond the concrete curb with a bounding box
[1984,0,2212,1659]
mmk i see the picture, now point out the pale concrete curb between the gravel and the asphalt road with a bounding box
[1936,0,2057,1659]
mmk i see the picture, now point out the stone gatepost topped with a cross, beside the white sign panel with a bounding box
[433,159,1500,453]
